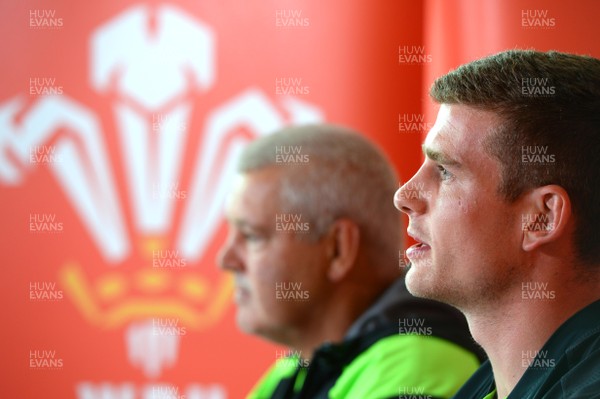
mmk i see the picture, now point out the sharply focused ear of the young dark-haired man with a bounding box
[521,184,571,251]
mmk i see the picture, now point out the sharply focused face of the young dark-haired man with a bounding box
[394,104,523,309]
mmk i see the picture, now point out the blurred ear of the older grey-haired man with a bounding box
[327,218,360,282]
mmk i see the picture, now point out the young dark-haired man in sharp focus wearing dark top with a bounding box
[395,51,600,399]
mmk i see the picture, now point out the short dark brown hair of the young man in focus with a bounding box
[430,50,600,265]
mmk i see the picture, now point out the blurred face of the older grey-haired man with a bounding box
[219,168,327,343]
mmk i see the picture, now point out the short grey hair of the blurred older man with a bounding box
[237,124,401,260]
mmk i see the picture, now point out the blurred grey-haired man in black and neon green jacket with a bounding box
[219,125,486,399]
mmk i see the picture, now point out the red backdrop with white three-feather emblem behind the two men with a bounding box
[0,0,600,399]
